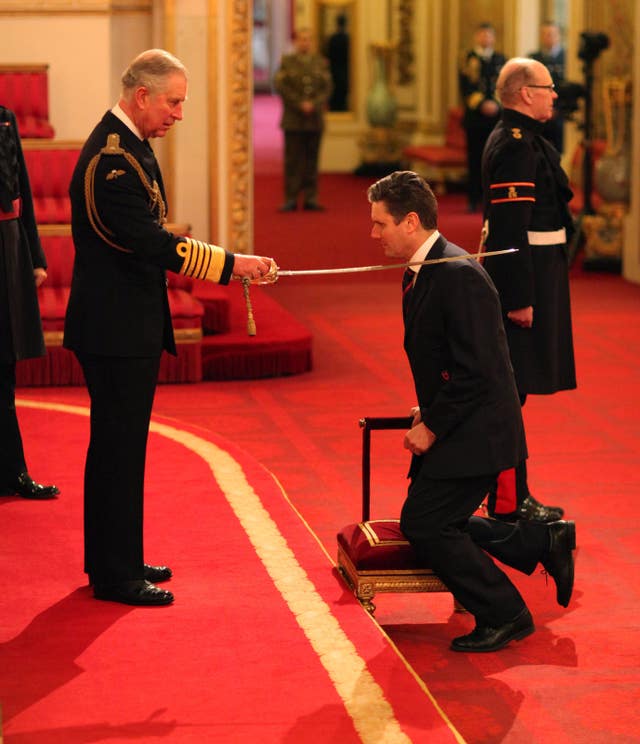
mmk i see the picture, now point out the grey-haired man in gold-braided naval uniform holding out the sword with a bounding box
[64,49,273,605]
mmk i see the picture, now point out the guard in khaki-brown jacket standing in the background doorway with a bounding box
[274,29,332,212]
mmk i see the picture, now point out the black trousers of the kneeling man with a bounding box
[400,473,548,627]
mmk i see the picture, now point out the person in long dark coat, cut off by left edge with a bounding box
[0,106,59,499]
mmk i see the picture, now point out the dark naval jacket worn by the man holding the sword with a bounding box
[64,112,233,357]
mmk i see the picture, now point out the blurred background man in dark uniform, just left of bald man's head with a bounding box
[459,23,505,211]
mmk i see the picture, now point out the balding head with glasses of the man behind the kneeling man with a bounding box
[496,57,558,121]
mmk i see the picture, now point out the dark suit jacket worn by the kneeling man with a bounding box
[404,236,527,478]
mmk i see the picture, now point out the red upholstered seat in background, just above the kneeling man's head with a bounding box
[402,108,467,194]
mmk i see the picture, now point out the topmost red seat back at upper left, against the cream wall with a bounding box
[0,65,54,139]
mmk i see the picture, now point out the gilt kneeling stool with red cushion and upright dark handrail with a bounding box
[337,417,462,614]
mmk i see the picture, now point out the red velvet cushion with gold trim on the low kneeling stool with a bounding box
[338,519,419,571]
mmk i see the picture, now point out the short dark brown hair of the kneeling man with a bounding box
[367,171,438,230]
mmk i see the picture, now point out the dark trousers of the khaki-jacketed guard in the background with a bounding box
[284,131,322,203]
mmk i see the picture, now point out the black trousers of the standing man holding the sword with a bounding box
[77,354,160,584]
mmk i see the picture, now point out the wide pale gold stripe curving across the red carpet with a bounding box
[16,400,464,744]
